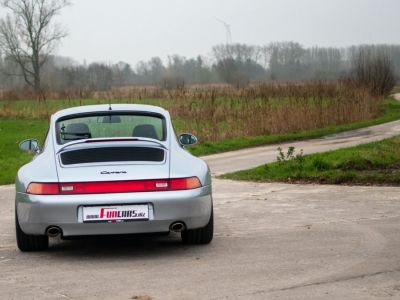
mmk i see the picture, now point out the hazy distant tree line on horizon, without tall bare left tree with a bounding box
[0,42,400,90]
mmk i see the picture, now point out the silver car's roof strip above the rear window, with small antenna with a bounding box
[52,104,168,120]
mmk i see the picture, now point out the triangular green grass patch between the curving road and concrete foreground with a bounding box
[221,136,400,186]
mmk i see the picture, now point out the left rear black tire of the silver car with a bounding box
[15,213,49,252]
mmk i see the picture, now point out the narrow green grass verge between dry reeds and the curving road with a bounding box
[190,98,400,156]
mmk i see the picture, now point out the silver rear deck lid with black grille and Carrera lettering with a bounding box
[57,142,169,182]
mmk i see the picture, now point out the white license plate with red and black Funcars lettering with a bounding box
[83,204,149,222]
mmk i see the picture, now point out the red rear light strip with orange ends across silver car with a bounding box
[26,177,201,195]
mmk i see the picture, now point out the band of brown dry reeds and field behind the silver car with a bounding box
[0,82,380,141]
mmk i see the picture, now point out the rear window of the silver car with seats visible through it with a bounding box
[56,112,166,144]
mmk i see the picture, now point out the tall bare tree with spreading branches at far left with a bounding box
[0,0,69,92]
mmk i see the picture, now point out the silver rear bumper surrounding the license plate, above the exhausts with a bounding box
[16,186,212,236]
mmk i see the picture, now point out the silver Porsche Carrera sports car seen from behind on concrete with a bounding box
[15,104,213,251]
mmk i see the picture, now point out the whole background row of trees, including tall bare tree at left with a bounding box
[0,0,400,94]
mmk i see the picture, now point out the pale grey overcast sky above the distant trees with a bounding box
[52,0,400,65]
